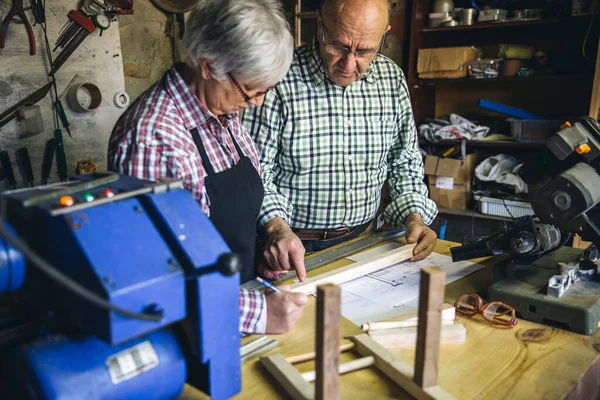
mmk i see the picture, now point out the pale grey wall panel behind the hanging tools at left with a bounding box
[0,0,125,190]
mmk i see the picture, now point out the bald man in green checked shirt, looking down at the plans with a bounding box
[243,0,437,280]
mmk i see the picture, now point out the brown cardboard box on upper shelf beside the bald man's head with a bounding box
[417,46,480,79]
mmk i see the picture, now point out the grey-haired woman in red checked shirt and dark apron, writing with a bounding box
[108,0,307,333]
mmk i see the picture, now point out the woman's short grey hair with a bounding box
[183,0,294,87]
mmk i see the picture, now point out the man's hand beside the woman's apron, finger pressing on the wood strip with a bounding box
[259,217,306,282]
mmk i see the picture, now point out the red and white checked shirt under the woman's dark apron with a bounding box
[108,64,266,334]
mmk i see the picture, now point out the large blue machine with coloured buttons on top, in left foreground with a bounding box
[0,174,241,400]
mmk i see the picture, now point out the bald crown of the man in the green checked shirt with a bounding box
[321,0,389,32]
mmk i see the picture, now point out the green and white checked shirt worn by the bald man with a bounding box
[243,40,437,229]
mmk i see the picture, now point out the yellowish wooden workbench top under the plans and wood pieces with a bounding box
[180,241,600,400]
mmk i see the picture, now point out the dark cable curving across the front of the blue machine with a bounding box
[0,219,163,322]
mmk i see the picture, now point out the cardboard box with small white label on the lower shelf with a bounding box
[425,154,478,210]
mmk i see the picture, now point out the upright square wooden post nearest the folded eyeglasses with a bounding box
[414,267,446,388]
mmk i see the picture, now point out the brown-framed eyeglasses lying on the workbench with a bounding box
[454,293,517,328]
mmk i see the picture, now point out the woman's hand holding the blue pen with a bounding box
[265,285,308,334]
